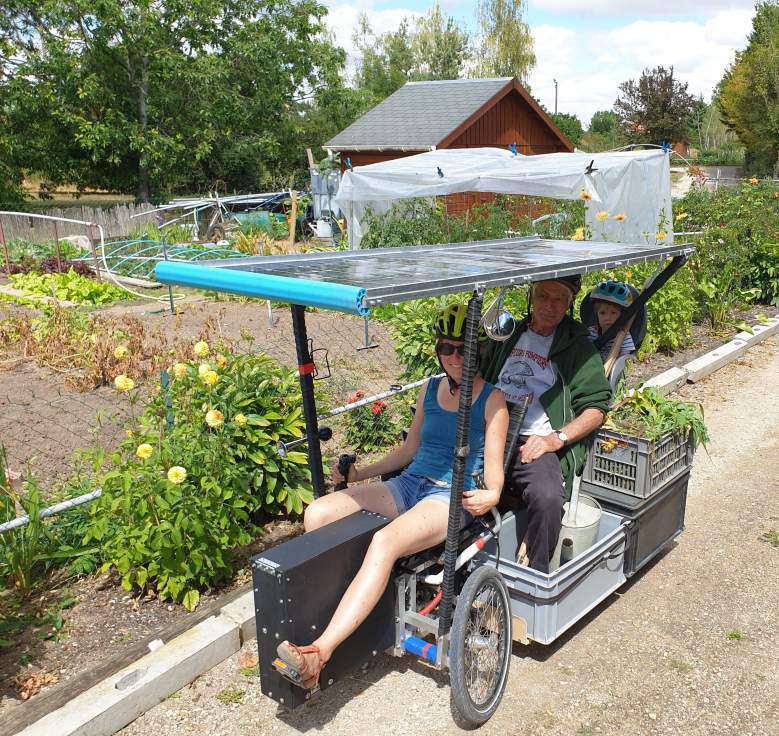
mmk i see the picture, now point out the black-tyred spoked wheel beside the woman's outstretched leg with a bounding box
[449,566,511,729]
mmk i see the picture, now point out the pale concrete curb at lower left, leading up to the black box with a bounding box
[20,591,256,736]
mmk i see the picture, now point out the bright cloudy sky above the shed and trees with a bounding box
[324,0,754,126]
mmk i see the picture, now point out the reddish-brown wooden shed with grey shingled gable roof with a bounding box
[323,77,573,212]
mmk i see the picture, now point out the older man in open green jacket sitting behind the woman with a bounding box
[481,276,611,572]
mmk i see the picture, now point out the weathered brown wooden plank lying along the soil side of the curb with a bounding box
[0,583,252,736]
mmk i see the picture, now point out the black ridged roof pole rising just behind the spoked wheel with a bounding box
[438,293,482,636]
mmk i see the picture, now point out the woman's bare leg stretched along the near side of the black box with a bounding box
[309,499,449,662]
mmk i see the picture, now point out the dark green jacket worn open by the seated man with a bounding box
[481,315,611,498]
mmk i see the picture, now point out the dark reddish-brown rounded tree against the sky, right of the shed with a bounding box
[614,66,695,143]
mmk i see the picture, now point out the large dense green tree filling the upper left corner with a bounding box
[0,0,344,201]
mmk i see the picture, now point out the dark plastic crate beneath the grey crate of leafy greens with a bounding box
[588,471,690,577]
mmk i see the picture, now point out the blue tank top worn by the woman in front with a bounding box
[406,378,495,490]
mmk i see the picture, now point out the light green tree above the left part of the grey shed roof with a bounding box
[354,4,470,105]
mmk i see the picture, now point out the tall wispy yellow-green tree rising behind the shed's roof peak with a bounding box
[477,0,536,83]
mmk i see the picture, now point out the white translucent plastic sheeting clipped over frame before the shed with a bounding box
[335,148,673,247]
